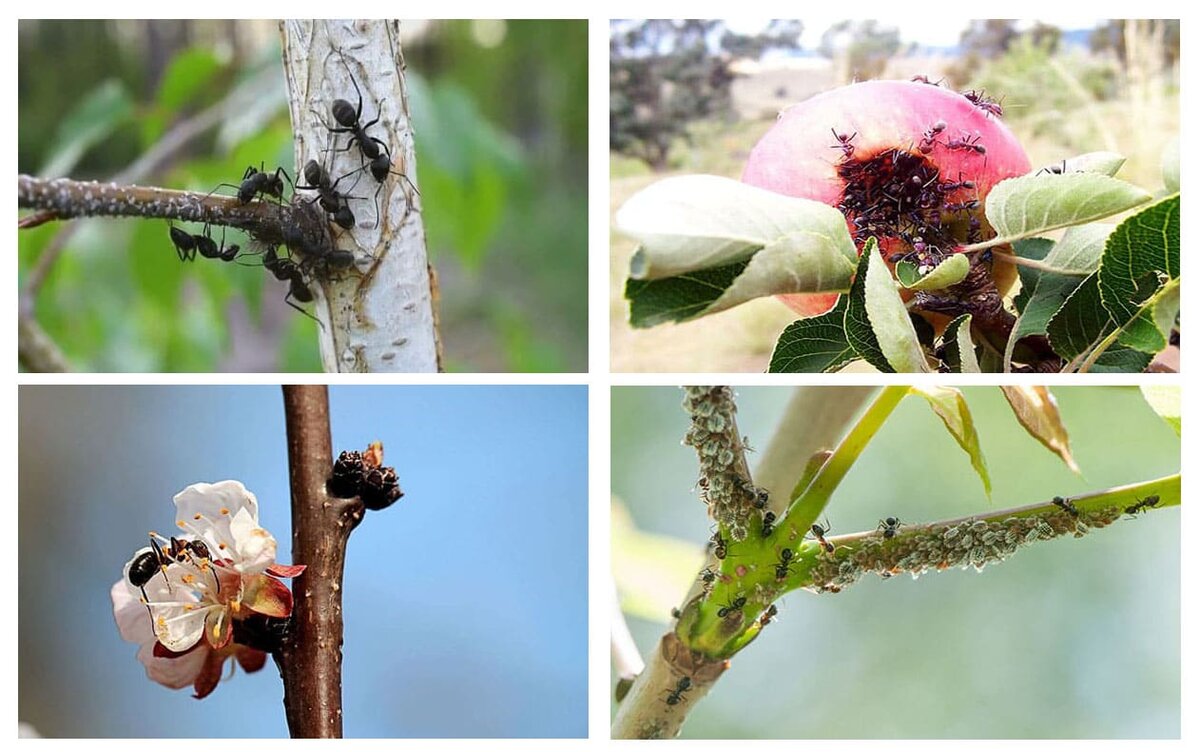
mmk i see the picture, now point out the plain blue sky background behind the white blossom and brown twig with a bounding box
[18,386,588,738]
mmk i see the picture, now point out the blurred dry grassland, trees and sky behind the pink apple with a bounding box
[608,17,1180,372]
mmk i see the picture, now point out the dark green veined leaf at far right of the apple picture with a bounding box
[1098,193,1180,326]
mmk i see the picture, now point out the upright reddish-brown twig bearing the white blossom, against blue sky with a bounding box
[275,385,364,739]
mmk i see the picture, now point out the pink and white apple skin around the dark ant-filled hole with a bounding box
[742,80,1031,317]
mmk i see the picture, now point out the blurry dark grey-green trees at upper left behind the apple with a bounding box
[608,19,804,170]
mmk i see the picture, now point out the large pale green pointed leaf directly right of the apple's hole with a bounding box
[986,173,1152,245]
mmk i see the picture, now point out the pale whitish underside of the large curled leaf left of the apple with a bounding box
[616,175,858,280]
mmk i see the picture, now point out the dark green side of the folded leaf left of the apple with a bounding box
[625,261,748,329]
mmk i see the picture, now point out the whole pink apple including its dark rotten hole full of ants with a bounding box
[742,82,1030,315]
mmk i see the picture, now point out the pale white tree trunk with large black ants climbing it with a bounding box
[281,20,440,373]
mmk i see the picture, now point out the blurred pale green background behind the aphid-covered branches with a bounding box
[610,387,1181,739]
